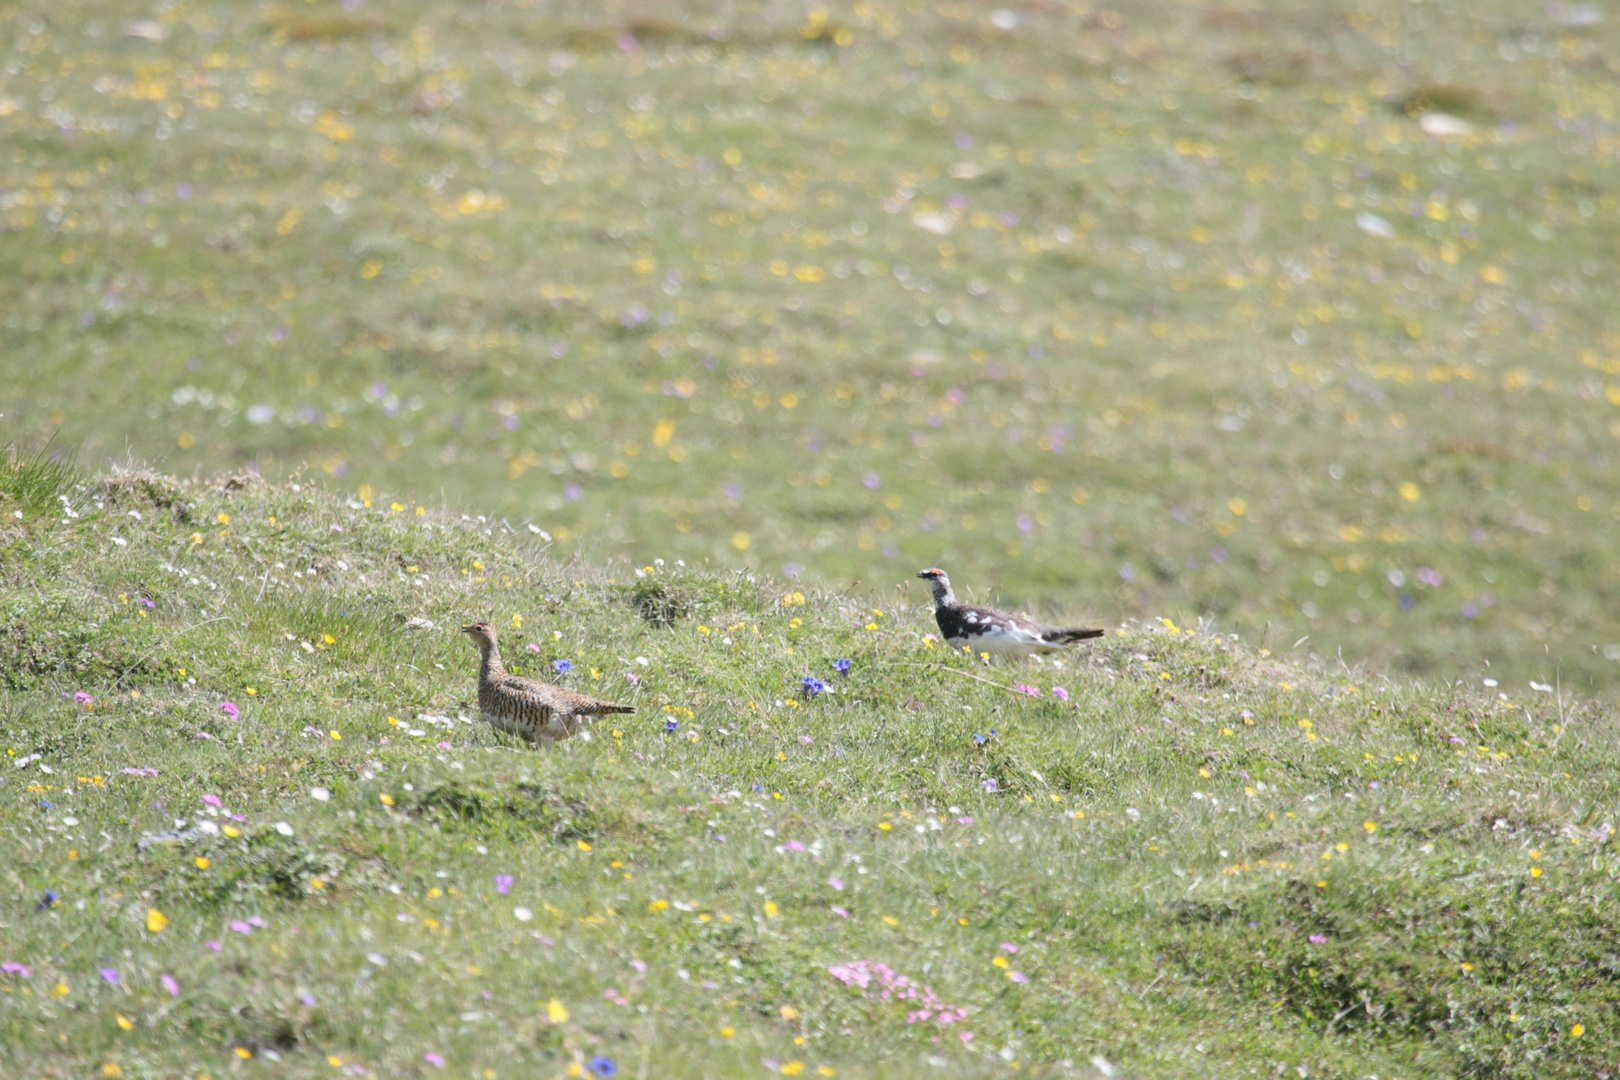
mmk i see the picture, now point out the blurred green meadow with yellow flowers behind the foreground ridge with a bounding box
[0,0,1620,693]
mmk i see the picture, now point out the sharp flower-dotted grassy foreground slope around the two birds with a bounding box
[0,474,1620,1077]
